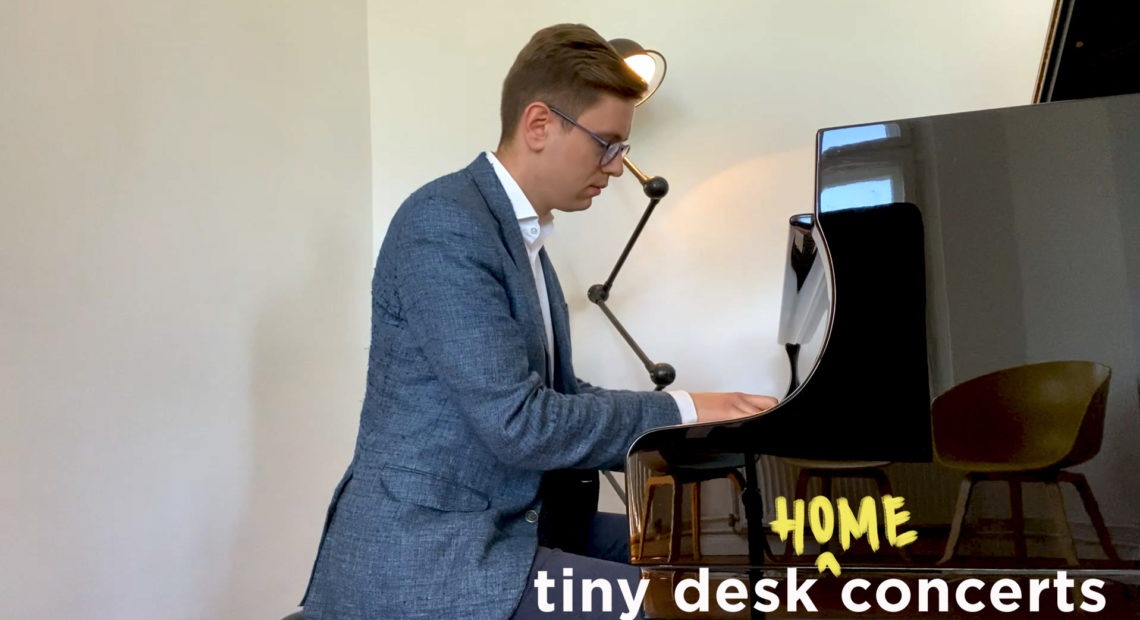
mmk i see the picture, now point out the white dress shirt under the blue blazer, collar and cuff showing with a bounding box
[487,150,697,424]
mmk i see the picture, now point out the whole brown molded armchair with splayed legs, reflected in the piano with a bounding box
[931,361,1119,565]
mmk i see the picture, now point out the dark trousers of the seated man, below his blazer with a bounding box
[511,513,643,620]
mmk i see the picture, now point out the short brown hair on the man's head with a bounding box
[499,24,648,144]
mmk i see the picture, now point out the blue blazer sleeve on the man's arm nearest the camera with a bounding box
[392,197,681,471]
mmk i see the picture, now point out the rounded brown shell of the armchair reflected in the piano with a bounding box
[931,361,1112,471]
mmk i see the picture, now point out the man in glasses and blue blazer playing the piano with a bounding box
[303,25,775,620]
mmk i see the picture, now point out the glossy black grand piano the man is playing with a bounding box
[626,90,1140,618]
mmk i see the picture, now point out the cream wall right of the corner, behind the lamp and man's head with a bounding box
[369,0,1052,509]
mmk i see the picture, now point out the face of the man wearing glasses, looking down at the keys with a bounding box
[542,95,634,211]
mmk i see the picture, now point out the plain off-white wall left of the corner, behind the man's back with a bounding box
[0,0,372,620]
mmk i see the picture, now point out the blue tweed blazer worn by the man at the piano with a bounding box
[303,155,681,620]
